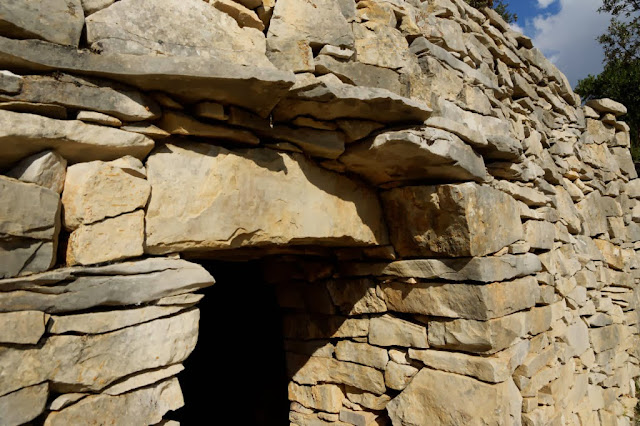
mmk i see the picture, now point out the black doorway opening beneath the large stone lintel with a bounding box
[167,261,289,426]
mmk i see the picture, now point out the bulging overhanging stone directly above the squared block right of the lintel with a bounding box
[340,128,488,185]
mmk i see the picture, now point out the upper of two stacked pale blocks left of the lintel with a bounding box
[62,161,151,232]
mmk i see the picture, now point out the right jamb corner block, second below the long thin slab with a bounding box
[429,312,530,354]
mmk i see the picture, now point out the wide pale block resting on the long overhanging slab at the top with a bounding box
[86,0,270,68]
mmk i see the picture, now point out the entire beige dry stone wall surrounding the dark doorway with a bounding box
[0,0,640,426]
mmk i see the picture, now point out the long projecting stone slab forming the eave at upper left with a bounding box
[0,37,295,117]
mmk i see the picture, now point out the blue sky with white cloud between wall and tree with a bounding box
[505,0,610,87]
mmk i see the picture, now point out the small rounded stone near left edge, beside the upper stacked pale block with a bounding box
[7,150,67,194]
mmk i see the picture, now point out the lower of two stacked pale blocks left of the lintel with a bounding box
[67,210,144,266]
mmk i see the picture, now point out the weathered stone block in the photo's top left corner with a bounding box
[0,0,84,46]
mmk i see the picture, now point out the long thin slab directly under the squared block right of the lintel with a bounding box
[344,253,542,283]
